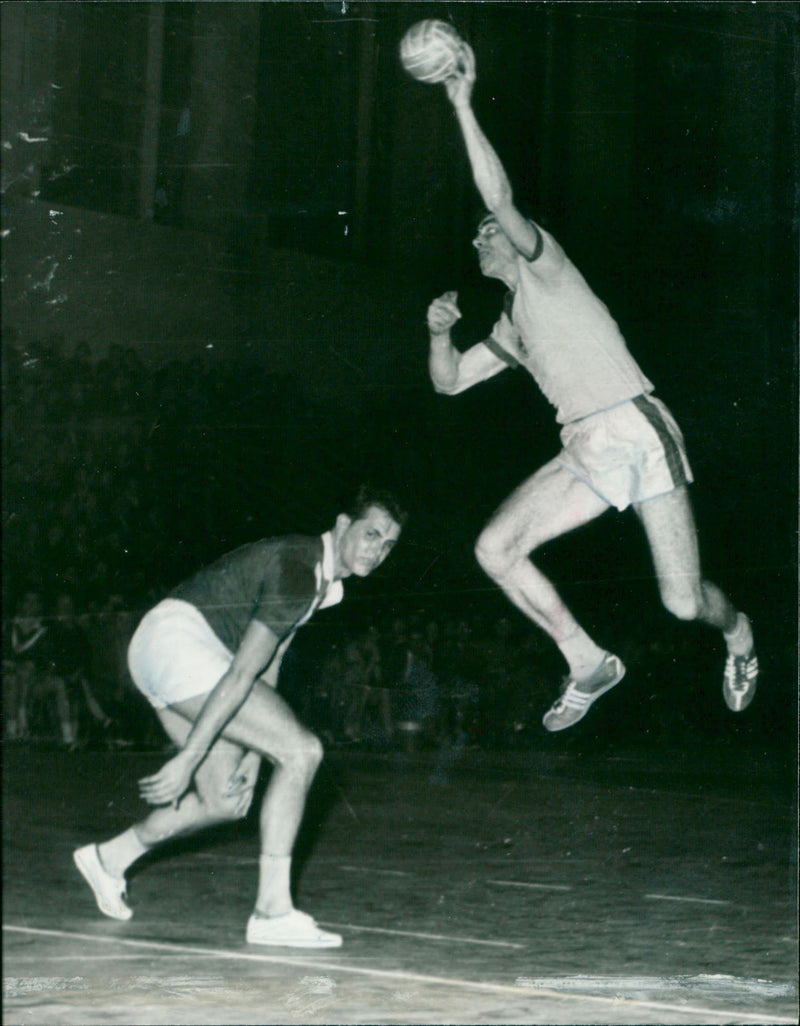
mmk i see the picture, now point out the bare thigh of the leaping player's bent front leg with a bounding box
[484,460,609,552]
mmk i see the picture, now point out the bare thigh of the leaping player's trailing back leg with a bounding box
[634,484,699,589]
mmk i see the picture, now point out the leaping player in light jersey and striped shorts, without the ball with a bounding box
[428,43,758,731]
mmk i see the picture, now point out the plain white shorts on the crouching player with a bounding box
[128,598,234,709]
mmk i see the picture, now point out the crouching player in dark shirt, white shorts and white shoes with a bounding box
[74,488,405,948]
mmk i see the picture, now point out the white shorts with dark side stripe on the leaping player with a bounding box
[557,395,693,510]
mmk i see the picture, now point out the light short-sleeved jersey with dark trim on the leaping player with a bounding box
[487,228,653,424]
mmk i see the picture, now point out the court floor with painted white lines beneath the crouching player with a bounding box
[3,739,798,1026]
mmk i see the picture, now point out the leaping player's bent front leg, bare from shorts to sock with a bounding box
[475,461,608,677]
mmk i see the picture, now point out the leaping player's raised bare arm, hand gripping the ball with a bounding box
[444,43,539,260]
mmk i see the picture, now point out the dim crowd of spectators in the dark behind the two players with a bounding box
[2,331,775,750]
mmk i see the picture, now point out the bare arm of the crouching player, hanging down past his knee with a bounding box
[139,620,279,805]
